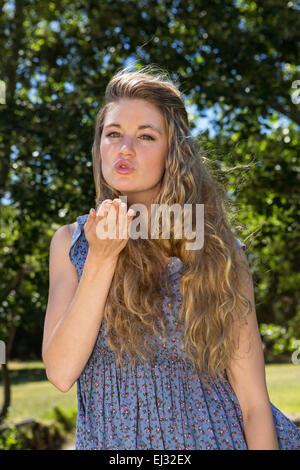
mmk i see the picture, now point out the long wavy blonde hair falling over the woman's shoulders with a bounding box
[92,66,251,378]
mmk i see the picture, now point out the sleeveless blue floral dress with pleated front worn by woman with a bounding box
[69,214,300,450]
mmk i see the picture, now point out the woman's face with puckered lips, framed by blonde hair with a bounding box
[100,99,167,205]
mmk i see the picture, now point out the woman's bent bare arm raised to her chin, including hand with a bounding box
[42,202,133,392]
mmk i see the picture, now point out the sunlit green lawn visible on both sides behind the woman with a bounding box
[0,362,300,422]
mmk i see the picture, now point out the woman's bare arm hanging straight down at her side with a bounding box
[226,250,278,450]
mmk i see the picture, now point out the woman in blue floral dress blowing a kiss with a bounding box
[43,67,300,450]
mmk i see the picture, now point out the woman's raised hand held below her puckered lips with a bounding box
[83,199,134,260]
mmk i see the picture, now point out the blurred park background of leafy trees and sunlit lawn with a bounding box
[0,0,300,449]
